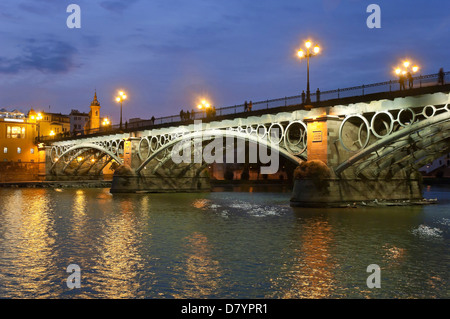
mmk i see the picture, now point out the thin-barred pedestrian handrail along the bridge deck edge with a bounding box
[38,71,450,142]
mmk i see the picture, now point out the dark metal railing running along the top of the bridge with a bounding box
[38,72,450,142]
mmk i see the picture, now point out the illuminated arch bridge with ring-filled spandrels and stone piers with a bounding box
[46,85,450,206]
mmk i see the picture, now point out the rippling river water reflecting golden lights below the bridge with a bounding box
[0,186,450,299]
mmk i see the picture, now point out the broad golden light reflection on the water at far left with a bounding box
[1,190,57,298]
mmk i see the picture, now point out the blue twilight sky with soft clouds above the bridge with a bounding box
[0,0,450,123]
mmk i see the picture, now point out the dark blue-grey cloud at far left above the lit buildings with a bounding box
[0,40,77,74]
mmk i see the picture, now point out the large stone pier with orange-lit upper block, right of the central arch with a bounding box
[291,115,422,207]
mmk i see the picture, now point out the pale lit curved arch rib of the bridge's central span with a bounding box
[136,129,304,174]
